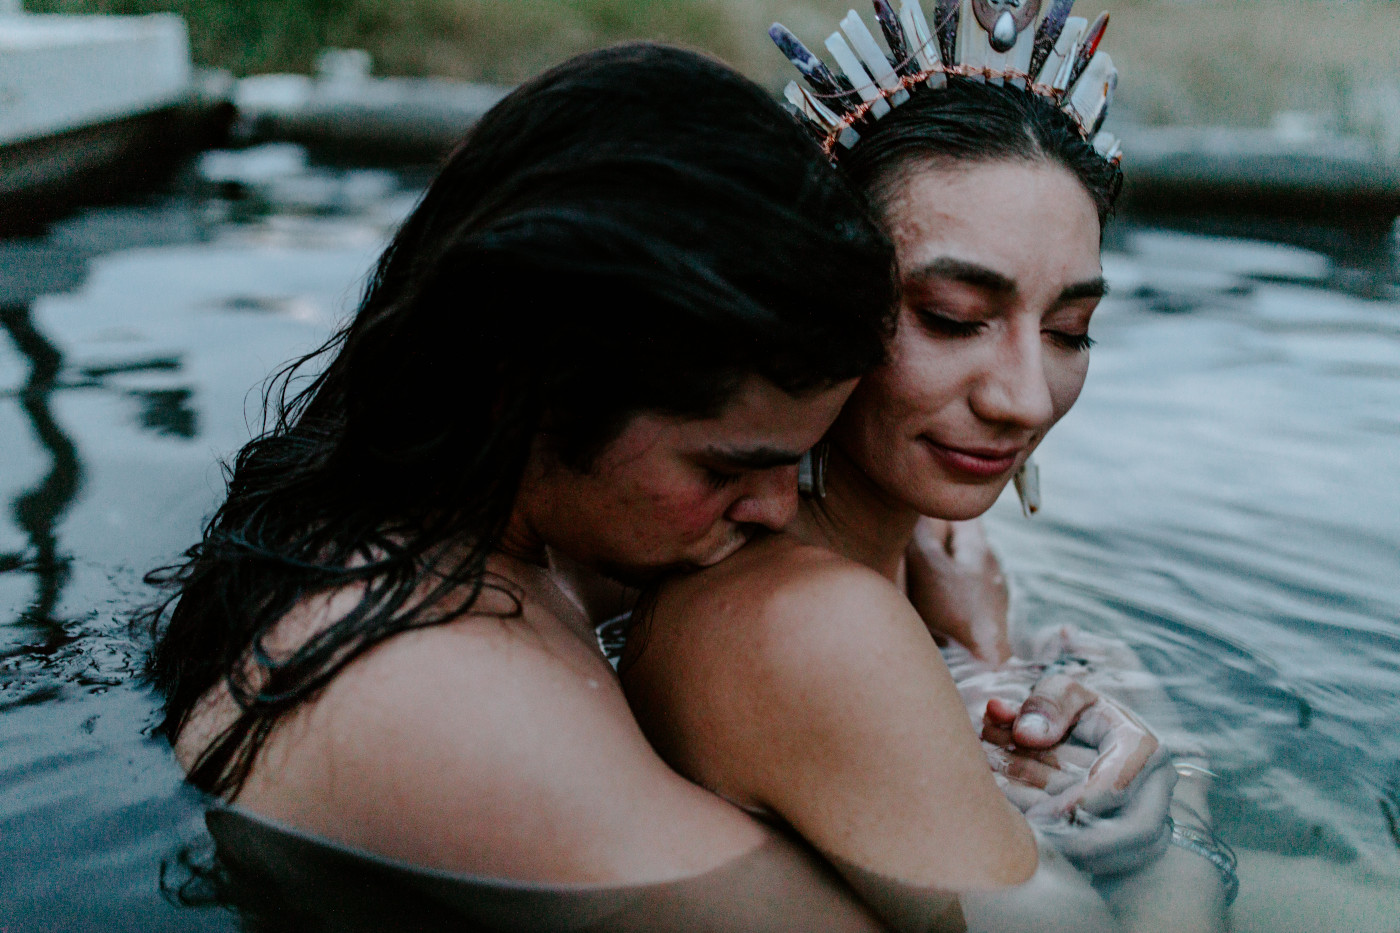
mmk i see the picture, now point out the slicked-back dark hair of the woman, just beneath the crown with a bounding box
[837,77,1123,227]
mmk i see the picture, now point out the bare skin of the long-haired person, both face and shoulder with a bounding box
[176,377,874,907]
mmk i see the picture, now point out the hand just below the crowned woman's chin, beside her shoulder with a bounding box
[904,518,1011,664]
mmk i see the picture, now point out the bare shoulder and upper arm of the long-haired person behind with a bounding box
[225,577,764,884]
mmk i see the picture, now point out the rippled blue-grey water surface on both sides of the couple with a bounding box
[0,158,1400,932]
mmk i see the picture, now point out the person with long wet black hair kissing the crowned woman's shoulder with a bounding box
[147,45,895,929]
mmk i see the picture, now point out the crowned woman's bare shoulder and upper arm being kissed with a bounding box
[623,529,1035,888]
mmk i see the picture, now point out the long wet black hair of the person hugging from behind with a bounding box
[139,45,896,794]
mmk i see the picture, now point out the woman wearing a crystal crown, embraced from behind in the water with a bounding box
[622,0,1233,930]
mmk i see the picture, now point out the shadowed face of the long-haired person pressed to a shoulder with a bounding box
[528,377,855,581]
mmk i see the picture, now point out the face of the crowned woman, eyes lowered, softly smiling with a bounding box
[834,161,1105,520]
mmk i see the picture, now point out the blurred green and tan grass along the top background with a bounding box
[25,0,1400,137]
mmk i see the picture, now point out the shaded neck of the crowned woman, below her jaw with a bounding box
[794,444,918,583]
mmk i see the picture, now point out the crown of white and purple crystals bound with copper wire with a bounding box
[769,0,1123,164]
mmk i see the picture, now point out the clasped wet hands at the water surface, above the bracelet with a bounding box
[983,675,1176,874]
